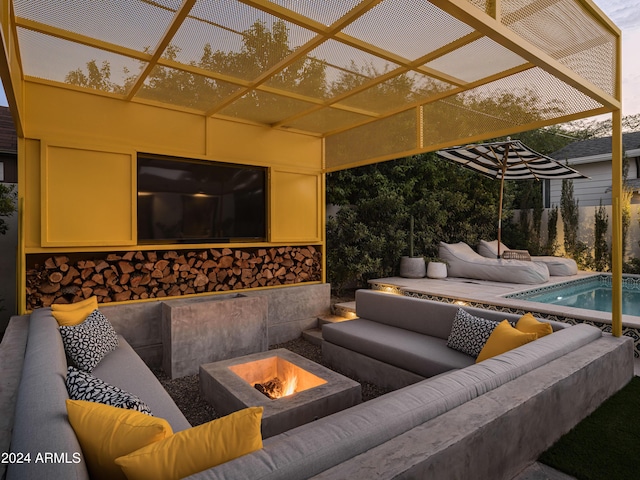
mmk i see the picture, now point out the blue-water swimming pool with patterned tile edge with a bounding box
[505,275,640,316]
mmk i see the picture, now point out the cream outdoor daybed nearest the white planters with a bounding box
[438,242,549,285]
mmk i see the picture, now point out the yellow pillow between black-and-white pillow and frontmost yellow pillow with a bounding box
[67,400,173,480]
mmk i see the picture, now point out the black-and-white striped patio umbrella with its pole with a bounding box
[436,137,587,258]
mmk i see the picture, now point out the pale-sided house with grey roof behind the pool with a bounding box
[544,132,640,208]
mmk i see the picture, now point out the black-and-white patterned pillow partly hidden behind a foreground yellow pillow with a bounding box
[65,367,153,416]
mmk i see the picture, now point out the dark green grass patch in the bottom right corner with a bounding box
[539,377,640,480]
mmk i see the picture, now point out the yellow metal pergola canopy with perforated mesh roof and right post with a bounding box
[0,0,622,335]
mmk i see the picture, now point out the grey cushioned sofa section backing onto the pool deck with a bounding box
[322,290,569,389]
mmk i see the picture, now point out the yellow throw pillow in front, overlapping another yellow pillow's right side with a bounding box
[116,407,263,480]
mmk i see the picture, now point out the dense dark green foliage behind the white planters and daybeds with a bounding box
[327,153,500,288]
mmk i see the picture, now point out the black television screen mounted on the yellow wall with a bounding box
[138,155,267,243]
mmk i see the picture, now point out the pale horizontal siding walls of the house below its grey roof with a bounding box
[549,159,640,207]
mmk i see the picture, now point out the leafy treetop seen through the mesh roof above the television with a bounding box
[65,20,327,111]
